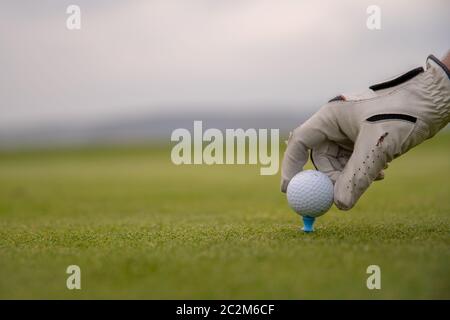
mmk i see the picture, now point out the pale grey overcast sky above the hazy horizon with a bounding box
[0,0,450,128]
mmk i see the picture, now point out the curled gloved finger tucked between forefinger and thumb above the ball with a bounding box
[311,140,353,183]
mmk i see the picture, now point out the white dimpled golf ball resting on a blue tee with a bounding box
[287,170,334,218]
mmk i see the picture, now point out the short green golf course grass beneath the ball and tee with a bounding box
[0,134,450,299]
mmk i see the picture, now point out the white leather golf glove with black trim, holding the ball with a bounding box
[281,55,450,210]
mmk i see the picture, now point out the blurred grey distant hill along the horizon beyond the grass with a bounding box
[0,113,307,149]
